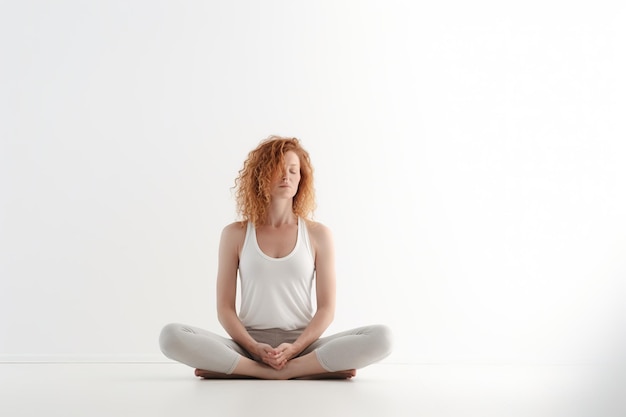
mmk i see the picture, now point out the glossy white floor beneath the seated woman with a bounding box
[0,363,626,417]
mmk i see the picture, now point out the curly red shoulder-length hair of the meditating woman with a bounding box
[235,136,315,225]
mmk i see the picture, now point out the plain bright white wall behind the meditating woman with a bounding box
[0,0,626,363]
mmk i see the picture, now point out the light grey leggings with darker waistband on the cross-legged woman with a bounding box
[159,323,391,374]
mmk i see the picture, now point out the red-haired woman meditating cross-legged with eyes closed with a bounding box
[159,136,391,379]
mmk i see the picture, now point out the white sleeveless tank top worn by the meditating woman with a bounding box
[239,219,315,330]
